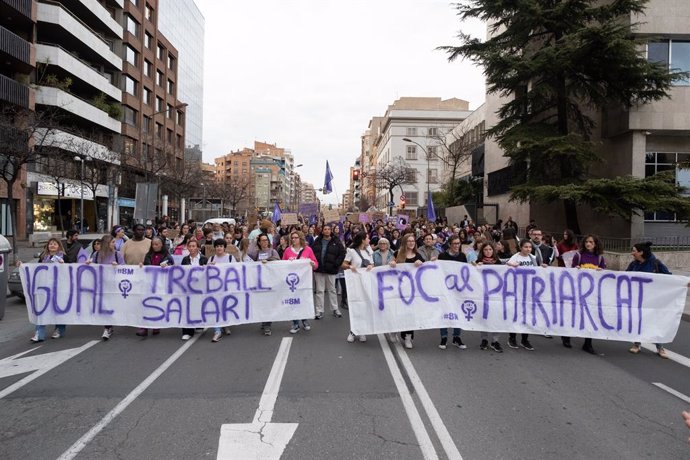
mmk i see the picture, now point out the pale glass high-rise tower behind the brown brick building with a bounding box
[159,0,205,161]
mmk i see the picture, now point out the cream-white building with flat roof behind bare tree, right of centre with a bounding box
[365,97,471,215]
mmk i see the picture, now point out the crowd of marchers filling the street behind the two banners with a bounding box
[25,216,670,358]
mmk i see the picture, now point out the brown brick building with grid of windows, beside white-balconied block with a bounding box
[119,0,187,221]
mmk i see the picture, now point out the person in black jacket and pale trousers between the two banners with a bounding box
[311,225,345,319]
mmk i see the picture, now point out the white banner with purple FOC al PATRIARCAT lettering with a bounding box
[345,261,688,343]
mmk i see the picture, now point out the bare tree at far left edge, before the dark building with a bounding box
[0,106,58,253]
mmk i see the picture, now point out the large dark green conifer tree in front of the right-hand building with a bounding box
[440,0,690,233]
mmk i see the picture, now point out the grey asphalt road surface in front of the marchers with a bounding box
[0,298,690,460]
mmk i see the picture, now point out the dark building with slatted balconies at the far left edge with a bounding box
[0,0,36,238]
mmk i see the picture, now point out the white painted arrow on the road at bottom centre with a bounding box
[216,337,299,460]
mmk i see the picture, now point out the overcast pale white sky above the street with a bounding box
[196,0,484,203]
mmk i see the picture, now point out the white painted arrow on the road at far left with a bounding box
[0,340,100,399]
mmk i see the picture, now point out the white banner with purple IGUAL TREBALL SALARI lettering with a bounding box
[19,260,314,328]
